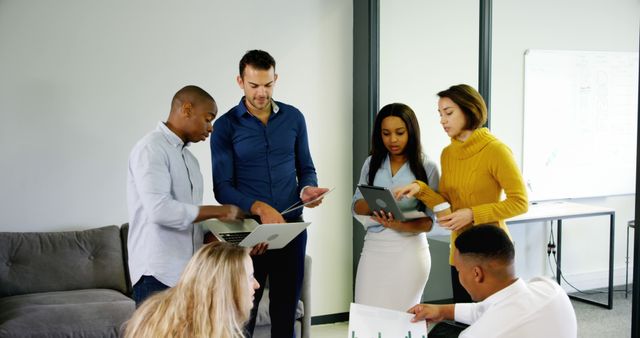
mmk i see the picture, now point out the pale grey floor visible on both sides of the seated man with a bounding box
[311,286,631,338]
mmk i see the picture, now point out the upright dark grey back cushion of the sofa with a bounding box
[0,225,127,297]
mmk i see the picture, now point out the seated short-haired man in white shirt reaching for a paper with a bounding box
[409,225,577,338]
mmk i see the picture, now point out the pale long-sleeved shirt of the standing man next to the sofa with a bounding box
[127,122,203,286]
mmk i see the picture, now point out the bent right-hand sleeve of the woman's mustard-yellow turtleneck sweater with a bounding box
[471,143,529,224]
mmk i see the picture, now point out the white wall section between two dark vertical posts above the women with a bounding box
[380,0,479,180]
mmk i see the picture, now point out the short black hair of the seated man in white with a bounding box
[456,225,515,262]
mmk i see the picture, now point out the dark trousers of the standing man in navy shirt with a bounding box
[245,230,307,338]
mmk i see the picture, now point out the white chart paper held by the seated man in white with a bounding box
[347,303,427,338]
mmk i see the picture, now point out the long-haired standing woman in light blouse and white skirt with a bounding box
[352,103,440,311]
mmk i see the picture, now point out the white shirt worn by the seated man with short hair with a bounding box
[455,277,578,338]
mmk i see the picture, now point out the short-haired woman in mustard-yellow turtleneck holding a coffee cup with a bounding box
[396,84,529,303]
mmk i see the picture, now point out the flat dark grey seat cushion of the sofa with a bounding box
[0,289,135,337]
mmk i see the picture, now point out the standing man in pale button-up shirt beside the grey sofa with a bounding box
[127,86,240,304]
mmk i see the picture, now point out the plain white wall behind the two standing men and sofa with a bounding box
[0,0,353,316]
